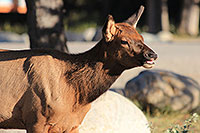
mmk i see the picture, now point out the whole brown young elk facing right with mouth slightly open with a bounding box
[0,7,157,133]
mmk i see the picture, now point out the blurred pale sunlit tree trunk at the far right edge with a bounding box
[178,0,200,36]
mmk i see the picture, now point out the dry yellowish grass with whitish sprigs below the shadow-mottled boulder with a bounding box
[146,112,200,133]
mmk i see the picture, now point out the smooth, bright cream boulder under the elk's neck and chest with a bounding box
[80,91,150,133]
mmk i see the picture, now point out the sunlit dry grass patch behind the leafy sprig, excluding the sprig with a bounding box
[147,113,200,133]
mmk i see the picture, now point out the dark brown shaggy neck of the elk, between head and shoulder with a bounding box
[66,40,124,104]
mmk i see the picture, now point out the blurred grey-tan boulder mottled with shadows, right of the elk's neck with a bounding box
[124,70,200,111]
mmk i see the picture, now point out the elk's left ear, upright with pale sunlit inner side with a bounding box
[102,15,116,42]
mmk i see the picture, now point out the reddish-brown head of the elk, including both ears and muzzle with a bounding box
[102,6,157,69]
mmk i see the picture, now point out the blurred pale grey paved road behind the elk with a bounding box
[0,41,200,88]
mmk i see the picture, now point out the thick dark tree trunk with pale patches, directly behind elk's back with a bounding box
[26,0,68,52]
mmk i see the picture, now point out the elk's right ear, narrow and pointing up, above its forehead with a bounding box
[125,6,144,28]
